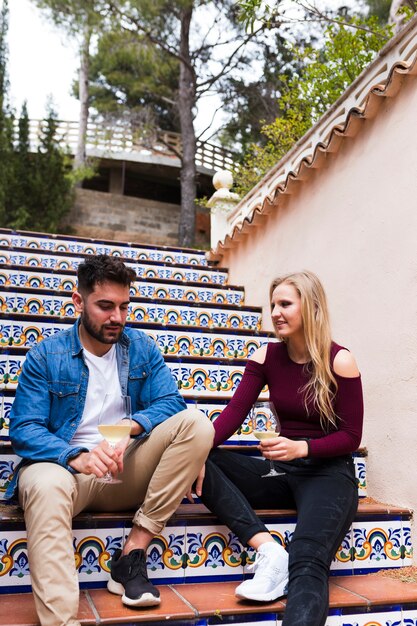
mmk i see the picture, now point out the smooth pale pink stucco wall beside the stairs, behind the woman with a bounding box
[221,76,417,545]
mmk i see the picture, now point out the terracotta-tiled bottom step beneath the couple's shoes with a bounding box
[0,574,417,626]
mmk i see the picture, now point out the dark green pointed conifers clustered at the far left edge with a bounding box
[0,1,79,232]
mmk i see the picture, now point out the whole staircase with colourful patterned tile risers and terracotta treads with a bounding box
[0,229,417,626]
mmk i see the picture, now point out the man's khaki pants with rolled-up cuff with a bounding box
[19,409,213,626]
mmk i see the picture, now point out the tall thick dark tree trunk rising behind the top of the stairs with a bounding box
[178,6,196,247]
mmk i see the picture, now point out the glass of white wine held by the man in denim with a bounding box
[96,393,132,484]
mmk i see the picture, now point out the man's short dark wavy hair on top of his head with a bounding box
[77,254,136,294]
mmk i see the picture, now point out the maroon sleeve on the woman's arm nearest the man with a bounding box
[213,359,266,448]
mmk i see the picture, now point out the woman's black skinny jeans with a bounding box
[202,449,358,626]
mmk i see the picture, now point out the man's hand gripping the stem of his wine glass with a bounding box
[68,438,125,478]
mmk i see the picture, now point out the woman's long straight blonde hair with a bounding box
[270,271,337,431]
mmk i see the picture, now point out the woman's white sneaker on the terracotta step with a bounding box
[235,542,288,602]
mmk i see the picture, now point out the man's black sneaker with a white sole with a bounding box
[107,549,161,606]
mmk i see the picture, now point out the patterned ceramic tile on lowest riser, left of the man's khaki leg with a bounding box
[0,531,30,593]
